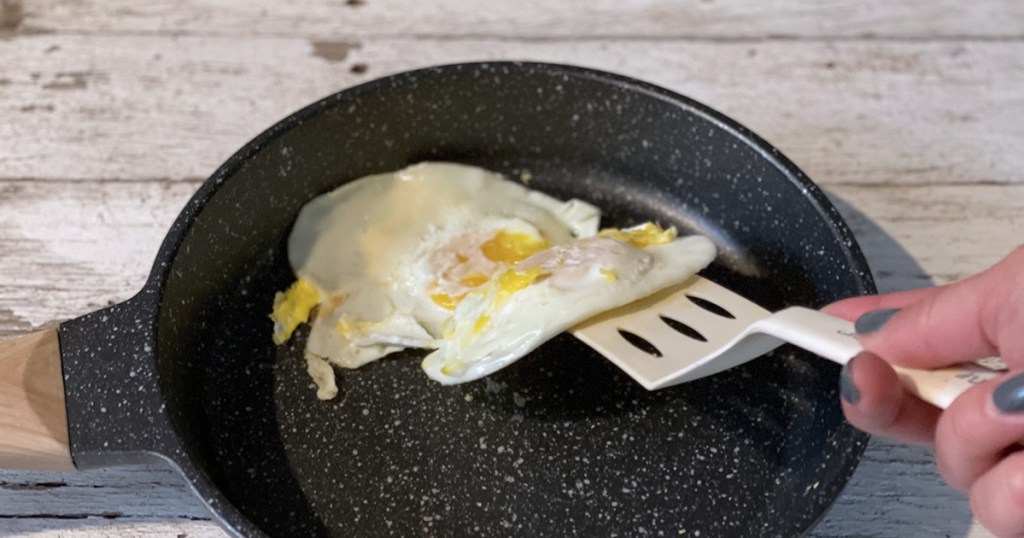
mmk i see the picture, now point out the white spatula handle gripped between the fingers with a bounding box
[770,306,1001,409]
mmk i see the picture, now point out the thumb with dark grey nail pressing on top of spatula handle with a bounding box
[856,247,1024,368]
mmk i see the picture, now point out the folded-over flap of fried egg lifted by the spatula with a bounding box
[423,229,715,384]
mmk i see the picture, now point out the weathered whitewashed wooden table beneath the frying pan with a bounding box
[0,0,1024,538]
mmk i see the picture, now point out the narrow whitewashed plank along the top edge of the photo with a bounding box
[12,0,1024,40]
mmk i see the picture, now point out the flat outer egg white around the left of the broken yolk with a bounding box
[288,163,600,389]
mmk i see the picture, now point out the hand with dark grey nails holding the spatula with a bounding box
[824,246,1024,536]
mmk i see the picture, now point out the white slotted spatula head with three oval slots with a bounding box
[571,276,781,390]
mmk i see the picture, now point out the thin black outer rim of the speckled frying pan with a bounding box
[136,60,876,536]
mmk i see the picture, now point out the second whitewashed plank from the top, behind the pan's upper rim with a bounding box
[0,35,1024,185]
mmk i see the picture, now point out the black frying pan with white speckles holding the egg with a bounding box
[0,63,876,537]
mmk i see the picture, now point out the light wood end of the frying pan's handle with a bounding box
[0,328,75,470]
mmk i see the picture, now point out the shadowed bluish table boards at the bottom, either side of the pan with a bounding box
[0,440,992,538]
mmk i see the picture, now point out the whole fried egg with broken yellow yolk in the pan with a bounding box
[271,163,715,400]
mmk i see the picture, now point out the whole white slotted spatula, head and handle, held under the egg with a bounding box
[571,276,1006,409]
